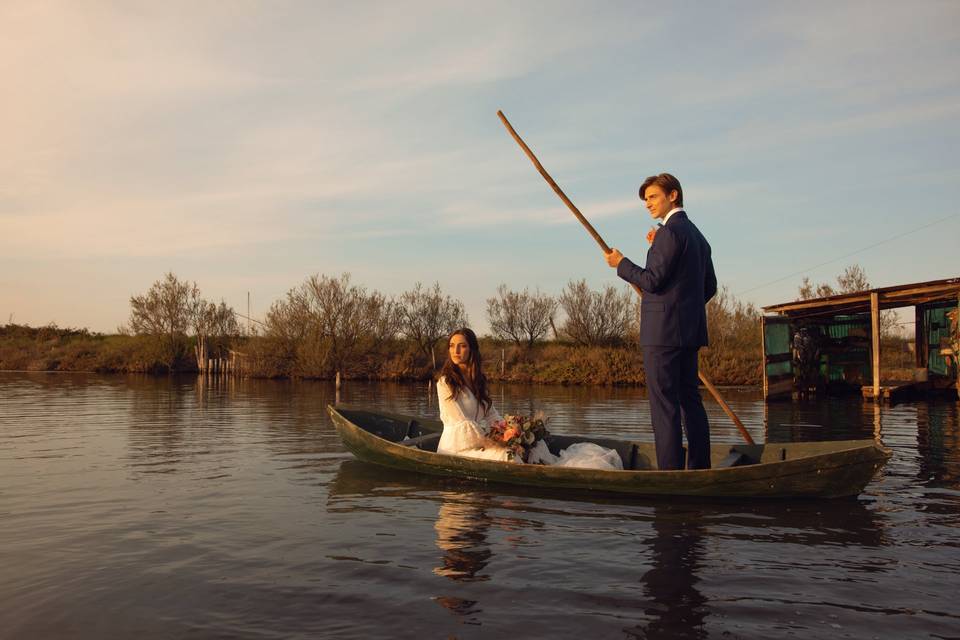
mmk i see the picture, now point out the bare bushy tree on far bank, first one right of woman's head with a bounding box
[487,284,559,348]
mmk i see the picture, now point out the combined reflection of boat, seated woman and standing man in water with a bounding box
[329,460,888,639]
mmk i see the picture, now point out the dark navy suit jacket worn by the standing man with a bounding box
[617,211,717,348]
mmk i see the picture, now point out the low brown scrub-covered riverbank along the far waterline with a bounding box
[0,325,761,386]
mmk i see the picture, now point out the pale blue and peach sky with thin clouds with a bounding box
[0,0,960,332]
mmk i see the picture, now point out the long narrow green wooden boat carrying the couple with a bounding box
[327,405,891,498]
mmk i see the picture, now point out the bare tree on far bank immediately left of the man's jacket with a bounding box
[560,280,635,346]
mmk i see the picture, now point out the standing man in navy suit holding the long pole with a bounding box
[606,173,717,470]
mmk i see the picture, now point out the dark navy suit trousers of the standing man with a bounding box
[643,346,710,470]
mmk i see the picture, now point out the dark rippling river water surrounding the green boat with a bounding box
[0,373,960,639]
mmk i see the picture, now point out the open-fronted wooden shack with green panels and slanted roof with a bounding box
[761,277,960,399]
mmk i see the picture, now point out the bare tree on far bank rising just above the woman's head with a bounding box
[400,282,467,371]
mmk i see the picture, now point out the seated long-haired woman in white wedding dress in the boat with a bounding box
[437,328,623,470]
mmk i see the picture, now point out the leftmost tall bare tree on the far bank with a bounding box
[130,272,201,371]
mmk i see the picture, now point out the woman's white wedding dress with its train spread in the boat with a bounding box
[437,378,623,471]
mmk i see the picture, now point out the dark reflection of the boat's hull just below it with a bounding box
[329,460,888,552]
